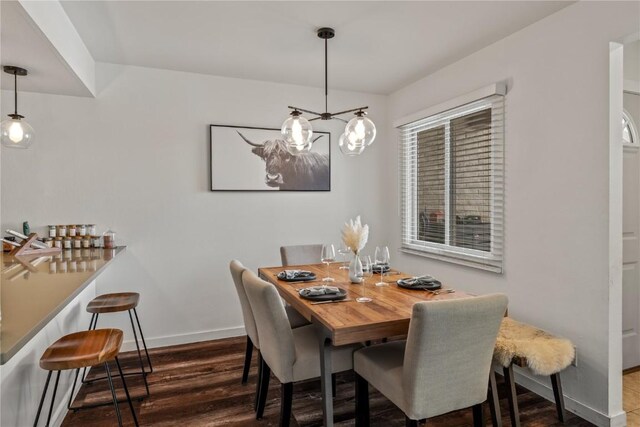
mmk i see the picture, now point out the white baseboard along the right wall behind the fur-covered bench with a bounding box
[514,368,627,427]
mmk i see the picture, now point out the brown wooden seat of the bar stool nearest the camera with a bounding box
[40,329,122,371]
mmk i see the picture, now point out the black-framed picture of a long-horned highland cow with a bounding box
[210,125,331,191]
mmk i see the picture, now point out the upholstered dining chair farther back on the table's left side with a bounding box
[229,260,309,407]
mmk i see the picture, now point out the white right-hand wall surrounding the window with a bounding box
[385,2,640,425]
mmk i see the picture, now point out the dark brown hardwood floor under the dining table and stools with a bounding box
[63,337,592,427]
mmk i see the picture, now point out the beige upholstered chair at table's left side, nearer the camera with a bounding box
[242,270,361,426]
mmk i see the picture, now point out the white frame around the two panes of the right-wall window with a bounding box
[394,84,506,273]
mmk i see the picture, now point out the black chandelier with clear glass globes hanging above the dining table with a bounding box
[282,27,376,156]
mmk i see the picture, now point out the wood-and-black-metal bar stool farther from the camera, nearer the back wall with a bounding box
[82,292,153,397]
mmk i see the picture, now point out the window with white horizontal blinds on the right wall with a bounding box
[399,91,504,272]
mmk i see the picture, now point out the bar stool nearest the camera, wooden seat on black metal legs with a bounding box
[33,329,138,427]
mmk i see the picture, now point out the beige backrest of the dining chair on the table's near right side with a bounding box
[402,294,508,419]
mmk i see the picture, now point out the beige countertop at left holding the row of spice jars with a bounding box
[0,246,125,364]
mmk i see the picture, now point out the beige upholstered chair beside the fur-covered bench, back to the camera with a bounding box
[353,294,507,427]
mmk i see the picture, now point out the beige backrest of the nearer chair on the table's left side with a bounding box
[242,270,296,382]
